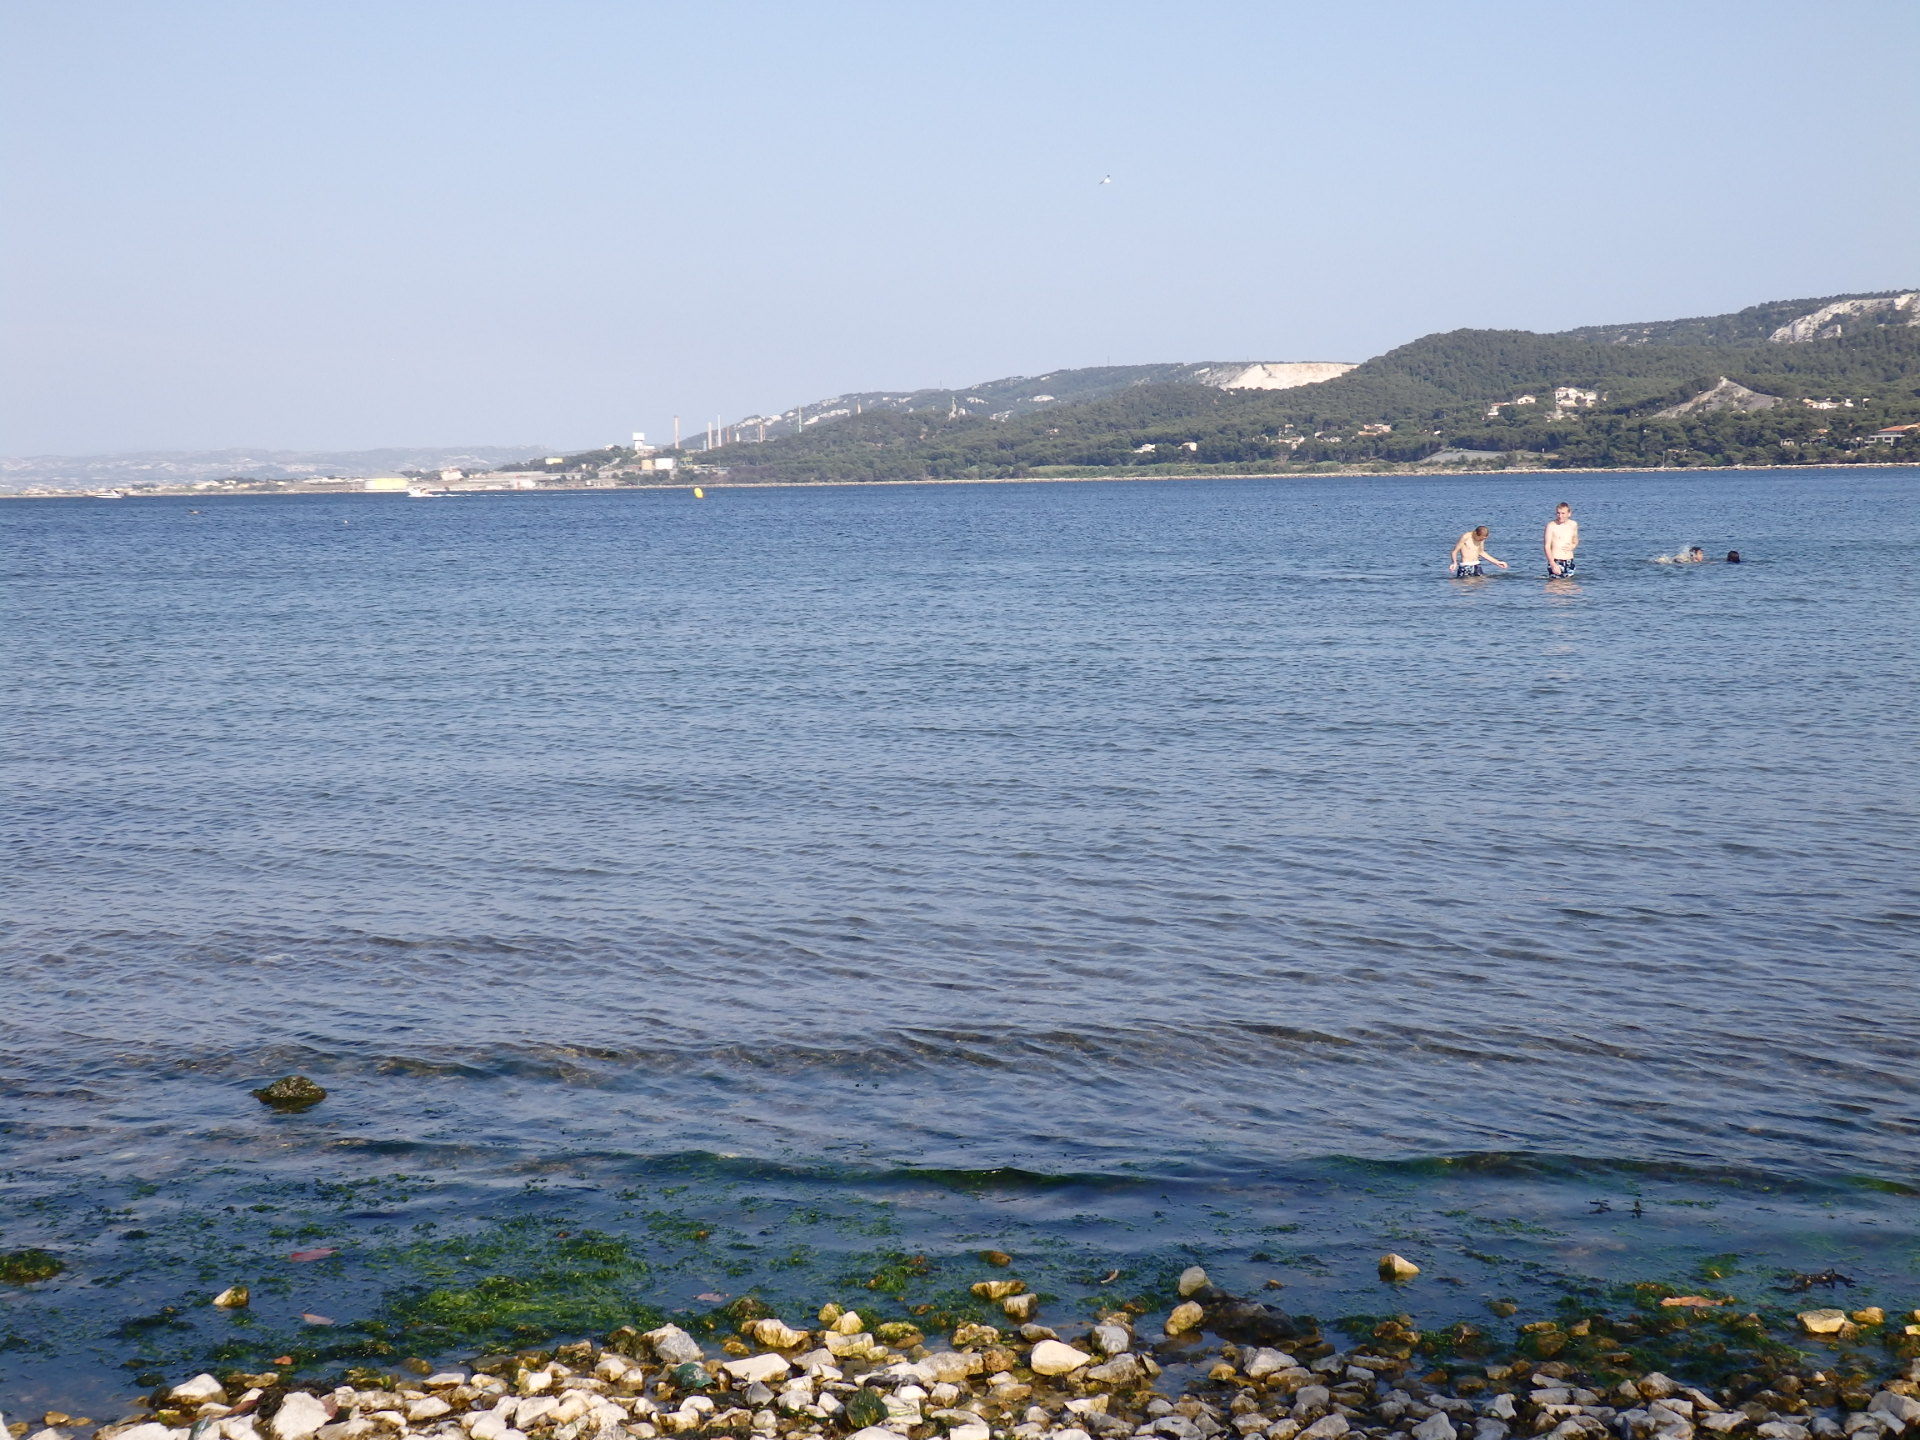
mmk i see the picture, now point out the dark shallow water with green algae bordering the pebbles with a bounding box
[0,1160,1914,1413]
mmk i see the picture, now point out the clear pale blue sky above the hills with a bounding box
[0,0,1920,455]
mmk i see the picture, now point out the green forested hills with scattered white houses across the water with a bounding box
[533,292,1920,482]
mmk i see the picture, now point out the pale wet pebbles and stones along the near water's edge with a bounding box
[0,1256,1920,1440]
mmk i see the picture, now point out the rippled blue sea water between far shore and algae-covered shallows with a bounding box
[0,470,1920,1413]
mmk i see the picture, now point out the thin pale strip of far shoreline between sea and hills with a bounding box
[0,461,1920,499]
